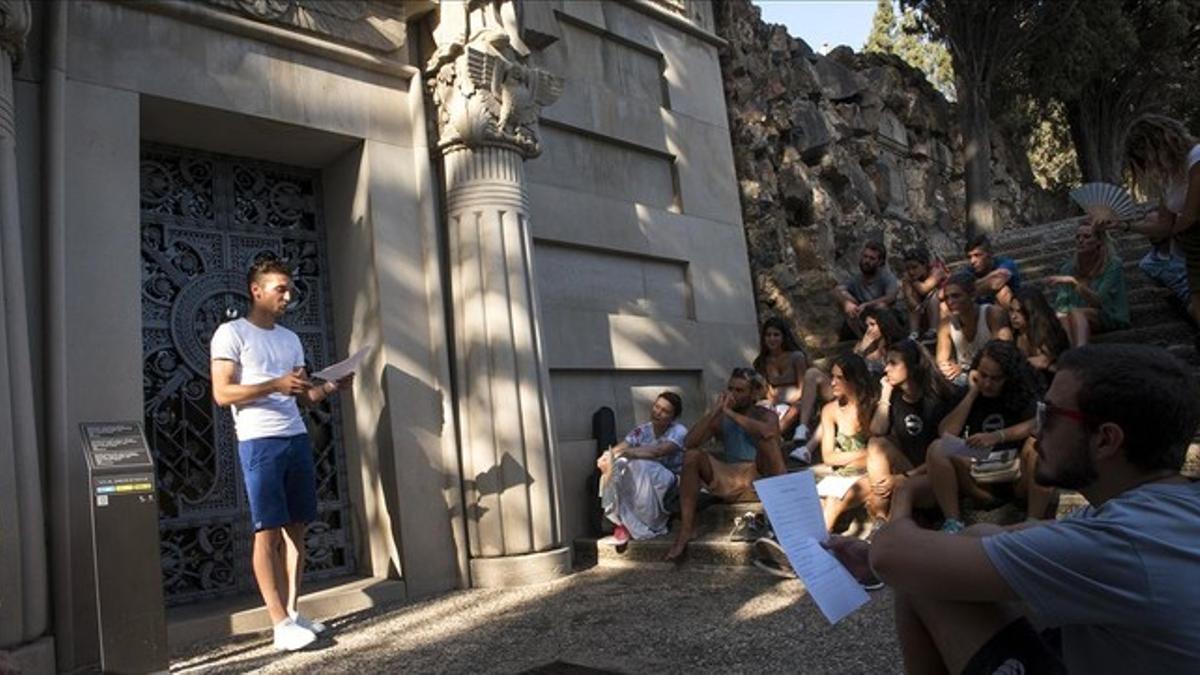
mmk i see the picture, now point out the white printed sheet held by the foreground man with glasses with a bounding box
[755,471,869,623]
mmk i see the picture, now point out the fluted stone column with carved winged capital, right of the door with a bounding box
[428,0,570,586]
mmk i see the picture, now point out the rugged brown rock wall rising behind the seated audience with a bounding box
[715,0,1054,347]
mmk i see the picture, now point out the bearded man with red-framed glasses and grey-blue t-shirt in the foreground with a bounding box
[827,344,1200,673]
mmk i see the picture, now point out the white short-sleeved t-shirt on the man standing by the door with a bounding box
[210,318,306,441]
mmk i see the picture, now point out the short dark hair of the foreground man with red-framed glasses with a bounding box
[1058,344,1200,471]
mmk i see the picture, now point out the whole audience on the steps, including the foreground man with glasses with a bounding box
[598,115,1200,673]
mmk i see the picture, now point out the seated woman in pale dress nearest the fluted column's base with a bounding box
[596,392,688,543]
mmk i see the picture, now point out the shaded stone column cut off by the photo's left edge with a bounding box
[0,0,49,649]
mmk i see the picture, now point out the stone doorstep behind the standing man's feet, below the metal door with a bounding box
[167,578,408,655]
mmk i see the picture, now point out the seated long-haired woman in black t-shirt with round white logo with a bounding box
[866,339,962,526]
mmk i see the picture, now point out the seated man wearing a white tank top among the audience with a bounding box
[937,270,1013,387]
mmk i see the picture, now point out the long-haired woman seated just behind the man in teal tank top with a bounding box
[754,317,832,448]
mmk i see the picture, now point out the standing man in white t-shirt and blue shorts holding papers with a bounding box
[210,259,354,651]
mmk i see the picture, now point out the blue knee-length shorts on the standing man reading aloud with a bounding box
[238,434,317,532]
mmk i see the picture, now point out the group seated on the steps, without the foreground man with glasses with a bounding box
[596,196,1185,550]
